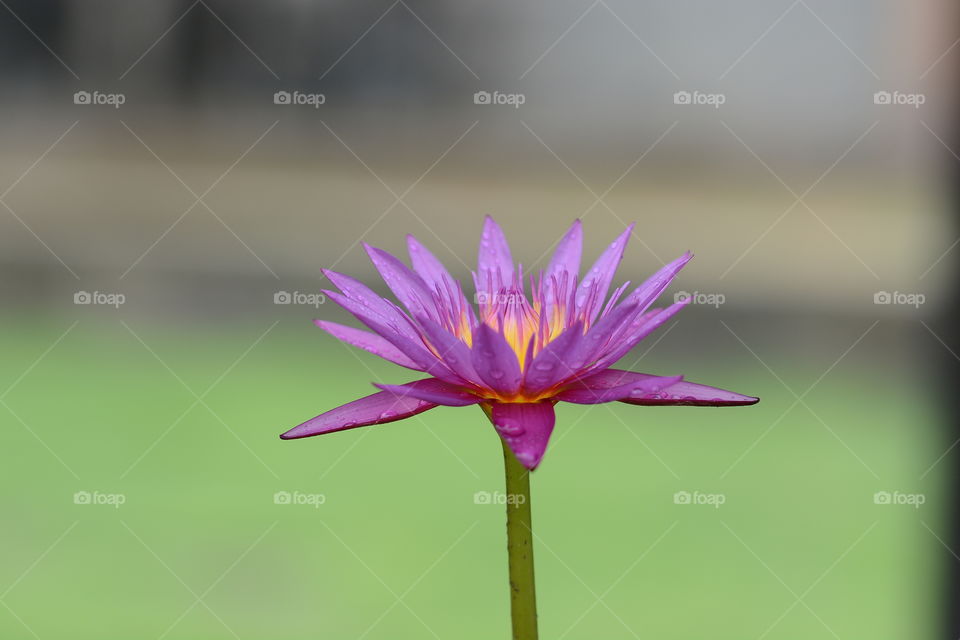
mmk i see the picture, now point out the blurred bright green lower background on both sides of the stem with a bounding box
[0,318,943,639]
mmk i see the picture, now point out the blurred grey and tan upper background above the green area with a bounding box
[0,0,955,313]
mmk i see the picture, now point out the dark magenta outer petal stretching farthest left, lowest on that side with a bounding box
[280,391,437,440]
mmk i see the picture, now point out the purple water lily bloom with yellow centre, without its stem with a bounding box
[281,217,758,469]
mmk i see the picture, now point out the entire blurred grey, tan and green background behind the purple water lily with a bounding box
[0,0,960,640]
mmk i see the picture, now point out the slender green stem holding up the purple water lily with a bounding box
[503,442,537,640]
